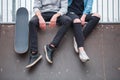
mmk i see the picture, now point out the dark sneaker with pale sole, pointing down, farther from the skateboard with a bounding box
[44,45,54,63]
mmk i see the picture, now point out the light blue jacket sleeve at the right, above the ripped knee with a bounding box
[83,0,93,14]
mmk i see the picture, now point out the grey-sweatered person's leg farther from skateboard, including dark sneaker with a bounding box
[44,15,71,63]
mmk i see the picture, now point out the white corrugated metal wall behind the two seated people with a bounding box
[0,0,120,23]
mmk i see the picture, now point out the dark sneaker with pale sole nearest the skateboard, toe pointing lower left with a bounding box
[26,54,42,68]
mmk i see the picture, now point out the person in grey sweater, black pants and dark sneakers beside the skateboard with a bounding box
[26,0,72,68]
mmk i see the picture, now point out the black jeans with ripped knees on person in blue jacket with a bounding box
[67,12,100,47]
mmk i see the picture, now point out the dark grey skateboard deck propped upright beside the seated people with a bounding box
[14,7,29,54]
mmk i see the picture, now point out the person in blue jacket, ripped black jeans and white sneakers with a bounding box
[67,0,100,62]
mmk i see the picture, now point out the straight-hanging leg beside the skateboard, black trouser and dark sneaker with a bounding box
[26,16,42,68]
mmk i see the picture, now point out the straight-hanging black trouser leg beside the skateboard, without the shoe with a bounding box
[29,16,39,52]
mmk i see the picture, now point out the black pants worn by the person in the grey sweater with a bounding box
[29,12,72,52]
